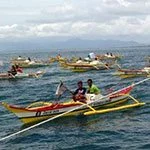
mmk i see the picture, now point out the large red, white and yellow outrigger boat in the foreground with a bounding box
[2,86,143,124]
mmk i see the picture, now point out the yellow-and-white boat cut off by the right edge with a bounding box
[114,67,150,78]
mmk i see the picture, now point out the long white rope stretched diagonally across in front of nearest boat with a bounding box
[0,78,150,141]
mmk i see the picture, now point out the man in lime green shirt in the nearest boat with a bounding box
[87,79,100,95]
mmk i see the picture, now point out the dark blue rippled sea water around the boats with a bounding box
[0,47,150,150]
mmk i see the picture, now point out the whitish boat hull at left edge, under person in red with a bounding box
[0,71,44,80]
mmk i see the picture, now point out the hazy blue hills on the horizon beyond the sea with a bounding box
[0,38,141,51]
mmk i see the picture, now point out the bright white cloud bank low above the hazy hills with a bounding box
[0,17,150,38]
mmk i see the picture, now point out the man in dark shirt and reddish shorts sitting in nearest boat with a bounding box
[73,81,86,103]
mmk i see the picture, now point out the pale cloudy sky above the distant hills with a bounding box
[0,0,150,43]
